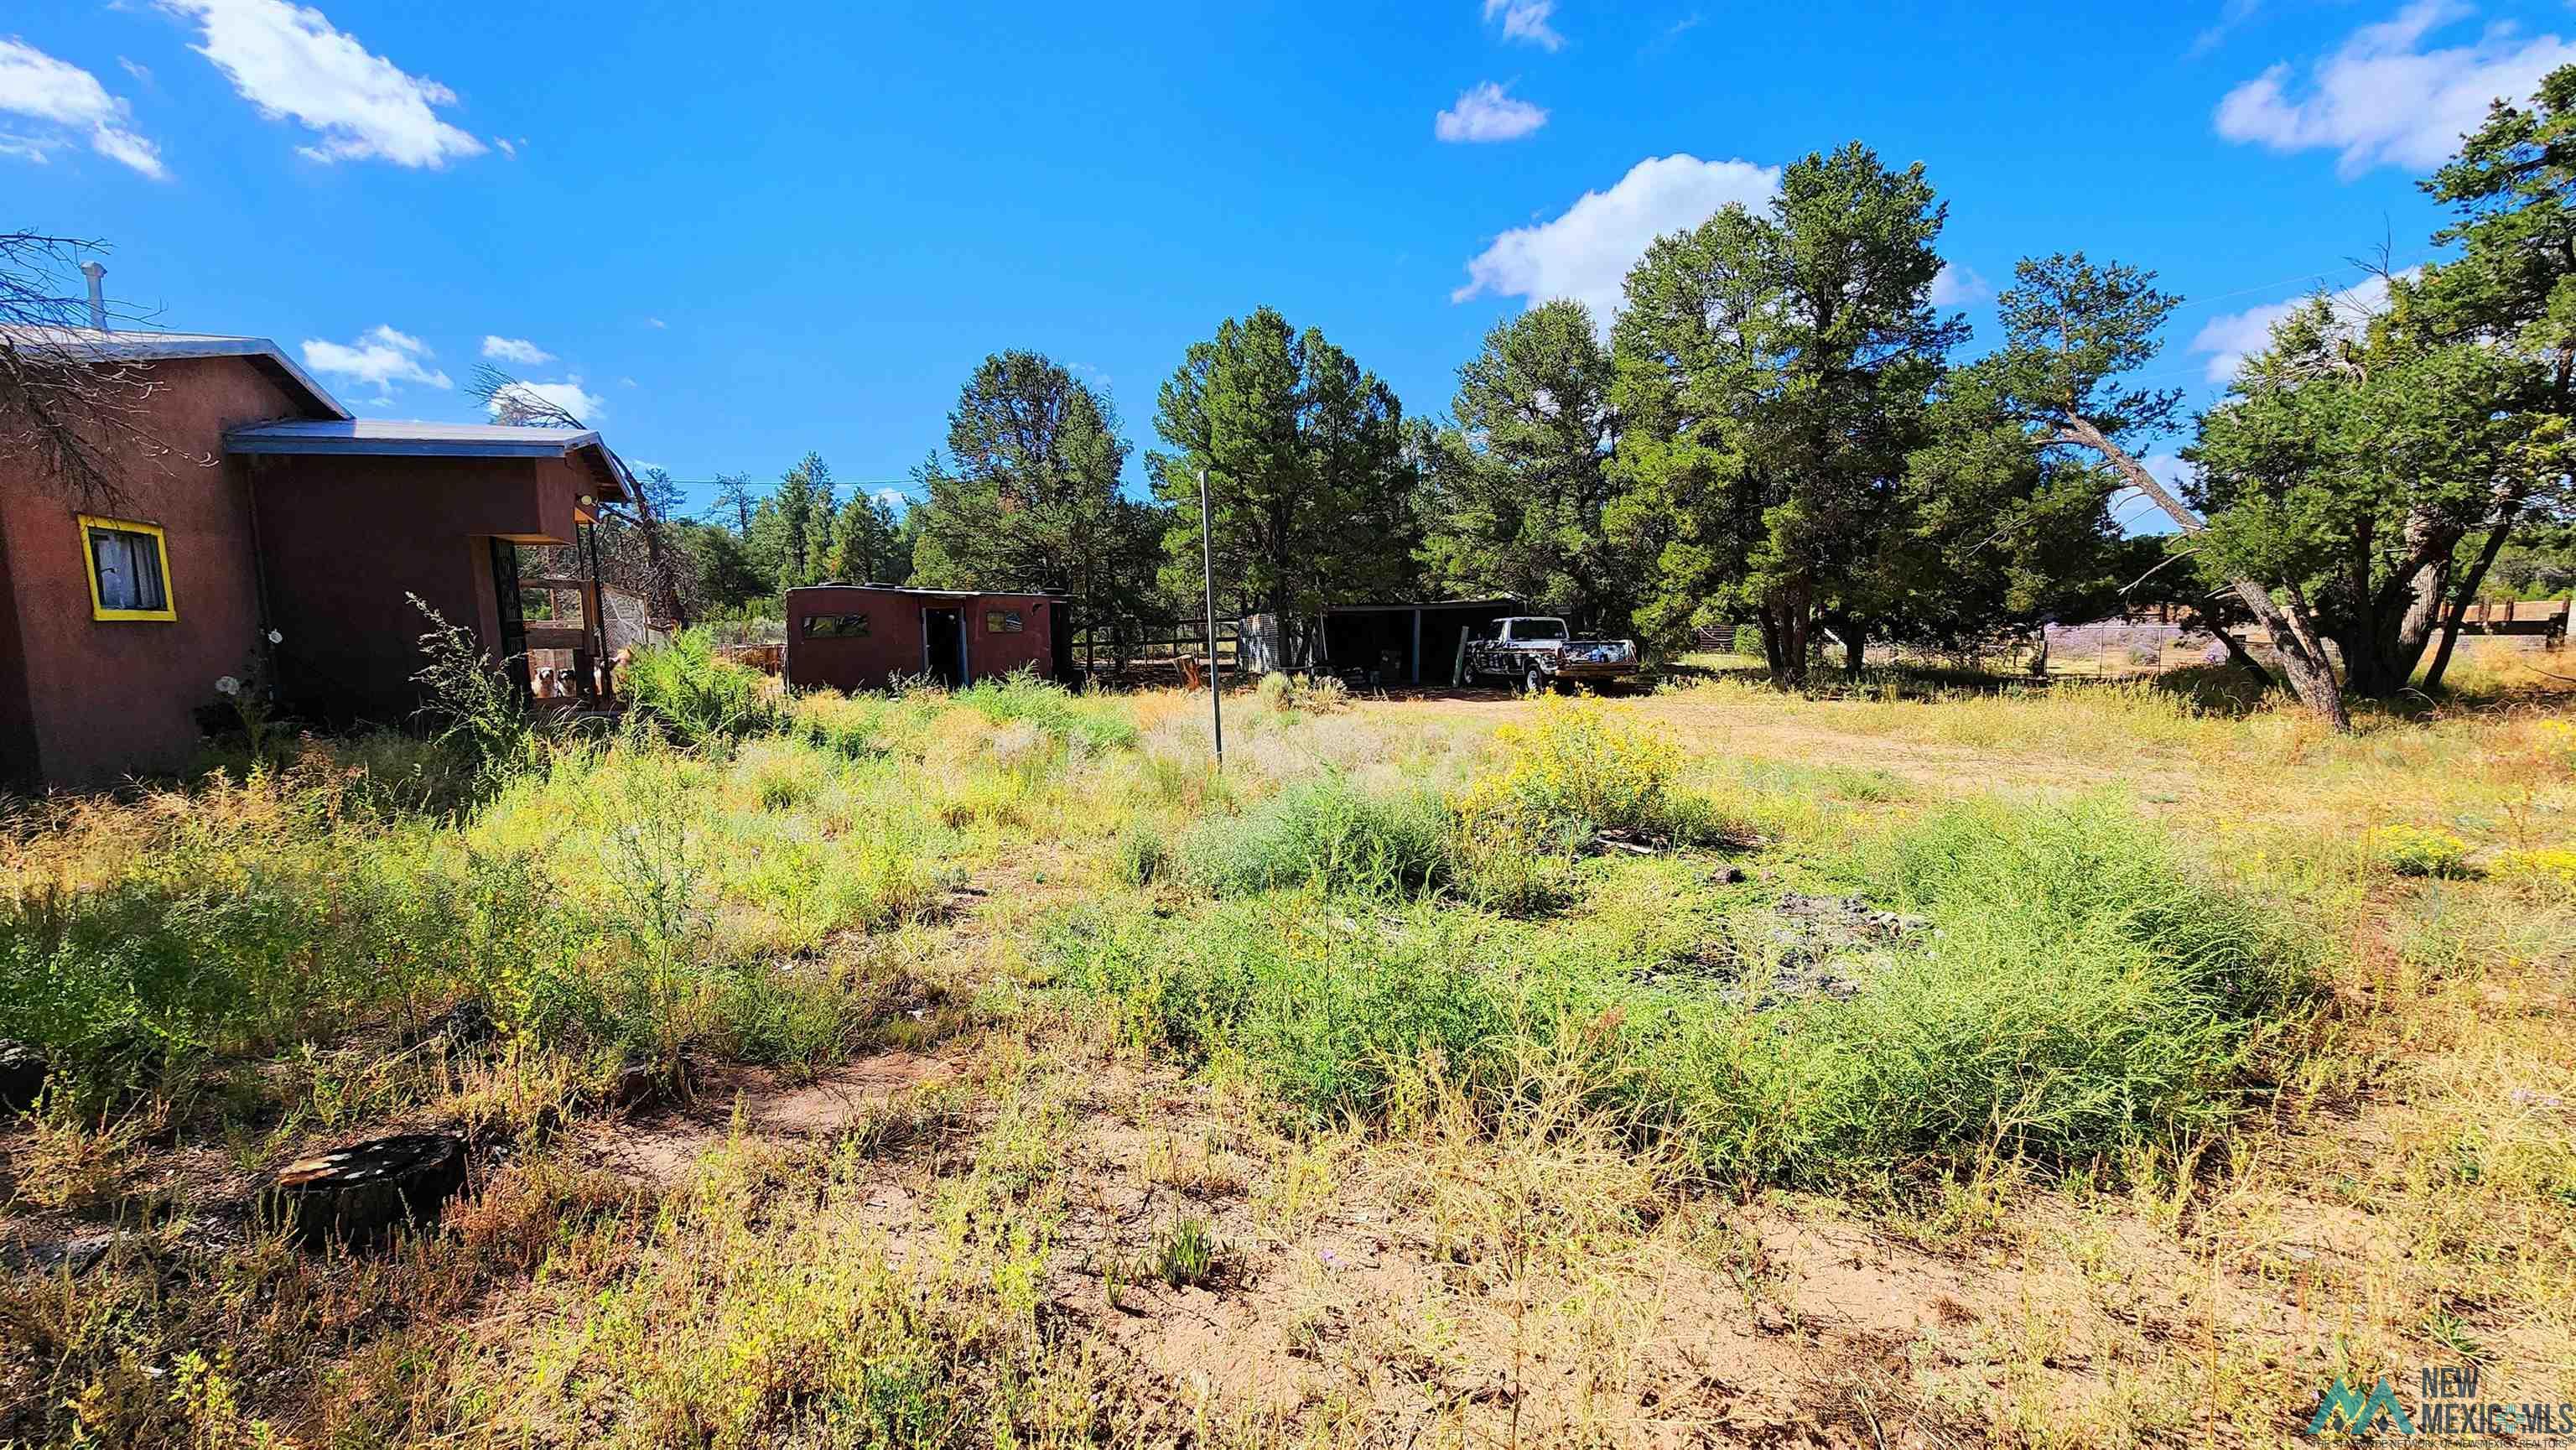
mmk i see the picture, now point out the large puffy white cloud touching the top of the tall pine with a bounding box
[1451,154,1780,327]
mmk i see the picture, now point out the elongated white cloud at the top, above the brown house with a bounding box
[163,0,485,170]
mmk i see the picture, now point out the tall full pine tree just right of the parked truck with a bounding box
[1613,142,1966,685]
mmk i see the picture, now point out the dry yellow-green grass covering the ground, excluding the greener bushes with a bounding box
[0,664,2576,1445]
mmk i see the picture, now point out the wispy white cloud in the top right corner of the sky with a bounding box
[2218,0,2576,178]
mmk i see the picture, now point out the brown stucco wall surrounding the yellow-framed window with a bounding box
[0,358,304,788]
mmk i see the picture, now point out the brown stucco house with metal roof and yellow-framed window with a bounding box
[0,327,626,788]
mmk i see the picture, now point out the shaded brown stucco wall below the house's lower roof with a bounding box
[255,456,595,724]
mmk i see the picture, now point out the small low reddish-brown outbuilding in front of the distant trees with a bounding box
[783,585,1074,690]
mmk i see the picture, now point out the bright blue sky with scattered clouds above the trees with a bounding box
[0,0,2576,522]
